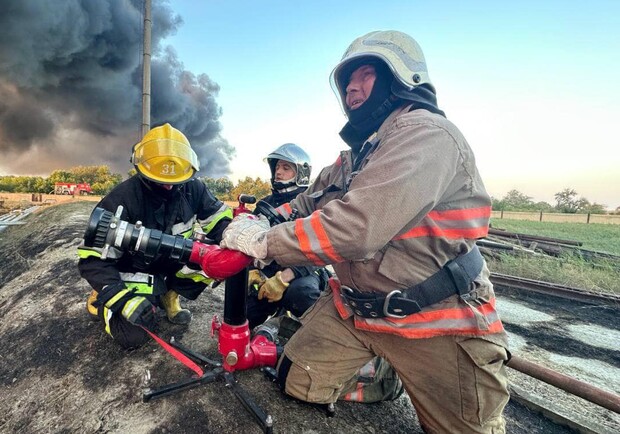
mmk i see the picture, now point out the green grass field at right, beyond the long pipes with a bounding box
[488,219,620,293]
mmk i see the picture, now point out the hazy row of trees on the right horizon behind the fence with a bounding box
[491,188,607,214]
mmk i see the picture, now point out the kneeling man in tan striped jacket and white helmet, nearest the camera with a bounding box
[221,31,509,433]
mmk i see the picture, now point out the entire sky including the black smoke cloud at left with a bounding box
[0,0,620,209]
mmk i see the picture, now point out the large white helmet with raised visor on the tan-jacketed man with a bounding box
[330,30,434,111]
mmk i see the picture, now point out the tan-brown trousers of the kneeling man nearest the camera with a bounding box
[279,290,509,434]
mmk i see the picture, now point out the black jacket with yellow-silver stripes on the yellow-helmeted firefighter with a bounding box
[78,175,232,295]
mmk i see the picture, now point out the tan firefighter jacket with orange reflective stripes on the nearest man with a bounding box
[267,106,505,344]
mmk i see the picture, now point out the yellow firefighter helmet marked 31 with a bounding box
[131,124,200,184]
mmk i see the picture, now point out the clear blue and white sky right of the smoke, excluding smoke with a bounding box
[168,0,620,208]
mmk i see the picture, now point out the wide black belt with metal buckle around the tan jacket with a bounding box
[340,244,484,318]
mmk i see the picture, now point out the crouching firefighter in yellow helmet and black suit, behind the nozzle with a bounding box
[78,124,232,348]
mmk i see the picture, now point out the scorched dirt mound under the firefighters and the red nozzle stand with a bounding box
[0,200,567,434]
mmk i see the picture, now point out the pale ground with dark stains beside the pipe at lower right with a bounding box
[497,288,620,433]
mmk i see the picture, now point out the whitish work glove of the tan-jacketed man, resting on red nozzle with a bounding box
[220,213,269,259]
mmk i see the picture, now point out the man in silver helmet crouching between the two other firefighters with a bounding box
[247,143,403,403]
